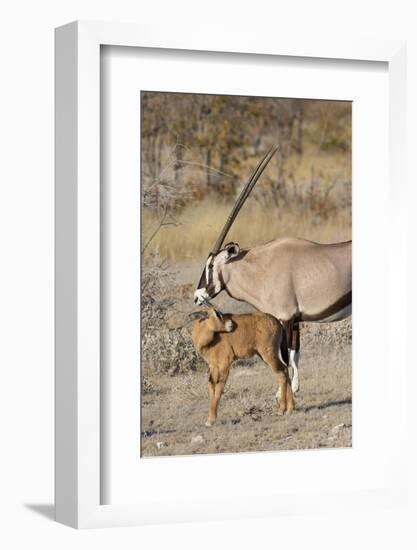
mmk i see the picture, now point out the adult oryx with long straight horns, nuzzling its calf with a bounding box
[194,149,352,392]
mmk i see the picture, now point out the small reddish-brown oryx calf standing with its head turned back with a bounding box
[192,308,294,426]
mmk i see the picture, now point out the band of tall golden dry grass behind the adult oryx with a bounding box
[142,201,351,263]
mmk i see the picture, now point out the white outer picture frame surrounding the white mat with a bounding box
[55,22,406,528]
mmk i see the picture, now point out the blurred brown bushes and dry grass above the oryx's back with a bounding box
[141,92,352,264]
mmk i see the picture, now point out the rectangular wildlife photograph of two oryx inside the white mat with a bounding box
[138,90,352,457]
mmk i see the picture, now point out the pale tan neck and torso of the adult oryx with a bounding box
[218,238,352,321]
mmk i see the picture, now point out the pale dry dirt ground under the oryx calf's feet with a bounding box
[141,322,352,457]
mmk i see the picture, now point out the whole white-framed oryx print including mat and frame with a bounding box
[56,22,406,527]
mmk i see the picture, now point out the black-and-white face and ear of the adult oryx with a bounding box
[194,243,240,305]
